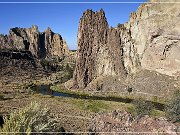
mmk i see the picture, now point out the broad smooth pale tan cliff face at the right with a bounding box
[125,0,180,76]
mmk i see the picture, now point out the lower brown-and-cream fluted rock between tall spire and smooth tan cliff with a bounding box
[107,24,140,75]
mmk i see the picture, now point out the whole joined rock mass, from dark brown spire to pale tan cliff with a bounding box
[73,0,180,89]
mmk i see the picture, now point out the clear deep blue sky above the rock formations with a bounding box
[0,0,146,49]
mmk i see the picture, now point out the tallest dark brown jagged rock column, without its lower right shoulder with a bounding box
[74,10,108,88]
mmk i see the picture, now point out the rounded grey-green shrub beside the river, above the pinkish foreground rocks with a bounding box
[133,98,154,117]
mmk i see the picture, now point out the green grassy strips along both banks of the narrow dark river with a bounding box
[51,84,165,117]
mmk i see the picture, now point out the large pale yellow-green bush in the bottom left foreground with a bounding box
[0,102,57,134]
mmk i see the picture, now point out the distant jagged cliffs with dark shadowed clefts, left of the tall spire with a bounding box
[0,25,69,58]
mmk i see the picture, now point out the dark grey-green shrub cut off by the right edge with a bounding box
[165,90,180,122]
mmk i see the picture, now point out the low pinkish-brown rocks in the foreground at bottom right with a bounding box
[90,110,180,135]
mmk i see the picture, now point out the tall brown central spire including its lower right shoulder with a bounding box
[74,10,126,88]
